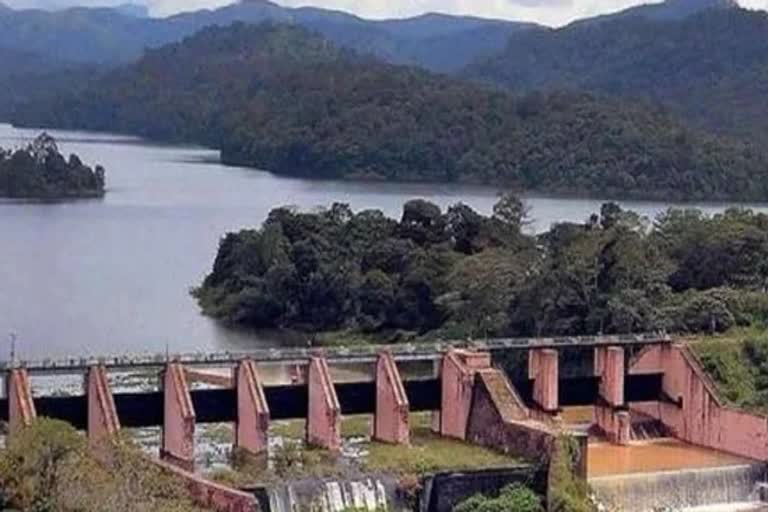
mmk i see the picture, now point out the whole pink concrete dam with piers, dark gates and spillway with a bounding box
[0,335,768,512]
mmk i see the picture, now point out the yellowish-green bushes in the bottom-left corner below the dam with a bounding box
[0,418,200,512]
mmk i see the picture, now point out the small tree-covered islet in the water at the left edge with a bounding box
[0,133,105,199]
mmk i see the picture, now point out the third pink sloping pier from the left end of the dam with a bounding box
[160,363,195,471]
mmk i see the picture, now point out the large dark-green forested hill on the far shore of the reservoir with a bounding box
[16,25,768,199]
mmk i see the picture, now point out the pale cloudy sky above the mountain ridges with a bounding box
[0,0,768,25]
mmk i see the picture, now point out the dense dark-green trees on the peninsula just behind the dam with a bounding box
[194,195,768,339]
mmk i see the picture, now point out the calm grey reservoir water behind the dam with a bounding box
[0,125,764,359]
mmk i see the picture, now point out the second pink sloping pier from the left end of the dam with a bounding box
[86,366,120,445]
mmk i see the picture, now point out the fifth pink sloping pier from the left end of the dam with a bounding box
[307,357,341,451]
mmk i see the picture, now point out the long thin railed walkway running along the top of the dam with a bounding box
[0,333,671,374]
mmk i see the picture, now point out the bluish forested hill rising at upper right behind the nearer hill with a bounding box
[465,3,768,145]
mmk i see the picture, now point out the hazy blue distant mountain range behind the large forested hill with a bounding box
[0,0,535,72]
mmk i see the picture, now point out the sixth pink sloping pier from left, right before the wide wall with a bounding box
[373,352,410,444]
